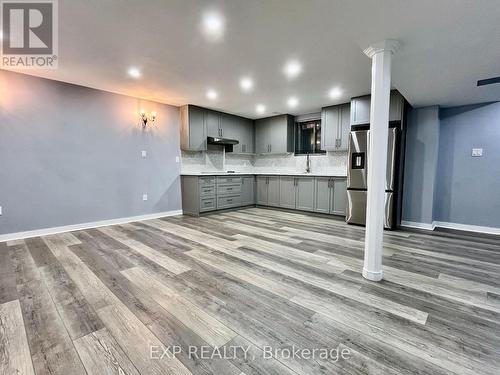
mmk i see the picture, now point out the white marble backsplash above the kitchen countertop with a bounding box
[181,150,347,175]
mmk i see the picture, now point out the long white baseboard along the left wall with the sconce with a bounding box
[0,210,182,242]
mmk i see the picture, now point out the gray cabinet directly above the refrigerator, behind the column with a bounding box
[351,90,404,125]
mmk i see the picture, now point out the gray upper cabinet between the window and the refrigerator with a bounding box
[321,103,351,151]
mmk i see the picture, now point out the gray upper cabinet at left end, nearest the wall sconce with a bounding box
[181,105,207,151]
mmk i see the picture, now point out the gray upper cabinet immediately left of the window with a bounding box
[255,115,294,154]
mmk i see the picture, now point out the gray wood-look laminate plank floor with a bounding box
[0,208,500,375]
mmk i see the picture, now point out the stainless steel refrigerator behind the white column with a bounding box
[346,127,399,229]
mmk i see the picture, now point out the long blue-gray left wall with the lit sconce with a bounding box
[0,71,181,234]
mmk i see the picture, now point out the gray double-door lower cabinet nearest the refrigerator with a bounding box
[314,177,347,215]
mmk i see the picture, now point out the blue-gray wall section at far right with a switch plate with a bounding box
[434,102,500,228]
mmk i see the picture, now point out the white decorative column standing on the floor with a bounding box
[363,40,399,281]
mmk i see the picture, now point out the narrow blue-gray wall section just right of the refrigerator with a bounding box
[402,106,440,224]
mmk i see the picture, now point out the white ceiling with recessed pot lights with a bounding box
[4,0,500,118]
